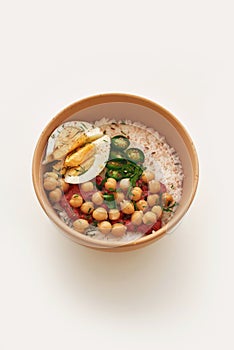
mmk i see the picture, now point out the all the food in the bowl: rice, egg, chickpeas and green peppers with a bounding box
[42,118,184,242]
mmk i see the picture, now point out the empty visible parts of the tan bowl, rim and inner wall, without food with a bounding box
[32,93,199,252]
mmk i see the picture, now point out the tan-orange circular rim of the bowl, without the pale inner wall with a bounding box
[32,92,199,251]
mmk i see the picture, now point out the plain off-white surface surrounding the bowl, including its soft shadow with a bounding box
[0,0,234,350]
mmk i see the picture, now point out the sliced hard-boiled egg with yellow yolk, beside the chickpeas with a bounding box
[43,121,111,184]
